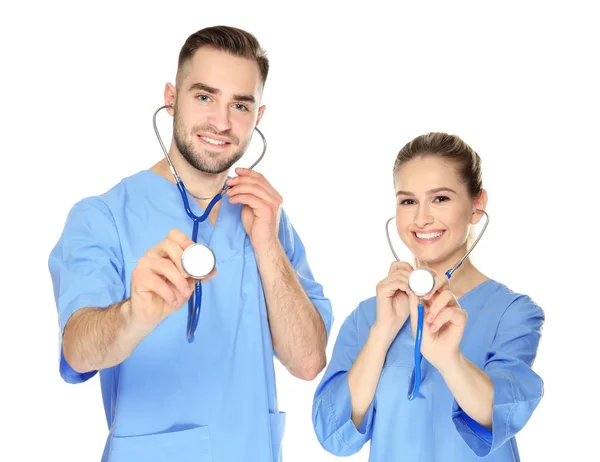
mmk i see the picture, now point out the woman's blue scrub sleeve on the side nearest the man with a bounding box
[312,311,375,456]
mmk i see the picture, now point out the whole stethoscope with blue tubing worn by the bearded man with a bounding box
[152,104,267,343]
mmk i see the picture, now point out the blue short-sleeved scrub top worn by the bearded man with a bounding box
[49,170,333,462]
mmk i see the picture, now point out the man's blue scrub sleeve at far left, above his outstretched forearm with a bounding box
[48,198,125,383]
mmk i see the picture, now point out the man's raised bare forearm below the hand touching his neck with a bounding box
[256,241,327,380]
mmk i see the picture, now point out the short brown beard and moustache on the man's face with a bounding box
[173,112,250,174]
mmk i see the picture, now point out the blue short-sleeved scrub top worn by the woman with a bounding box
[313,280,544,462]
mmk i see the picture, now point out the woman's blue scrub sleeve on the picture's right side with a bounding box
[452,296,545,457]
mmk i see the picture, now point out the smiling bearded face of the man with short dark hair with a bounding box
[173,47,265,173]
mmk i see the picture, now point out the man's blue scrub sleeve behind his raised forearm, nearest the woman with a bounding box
[279,211,333,339]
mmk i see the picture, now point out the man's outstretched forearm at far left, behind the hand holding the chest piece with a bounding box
[63,299,149,373]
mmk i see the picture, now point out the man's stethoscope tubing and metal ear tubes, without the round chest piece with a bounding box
[152,104,267,343]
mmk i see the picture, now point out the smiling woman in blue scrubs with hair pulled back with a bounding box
[313,133,544,462]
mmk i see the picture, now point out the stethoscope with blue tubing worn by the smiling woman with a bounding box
[385,209,490,401]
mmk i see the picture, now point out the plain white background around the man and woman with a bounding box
[0,0,600,462]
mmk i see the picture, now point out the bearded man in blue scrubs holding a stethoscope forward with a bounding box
[49,26,333,462]
